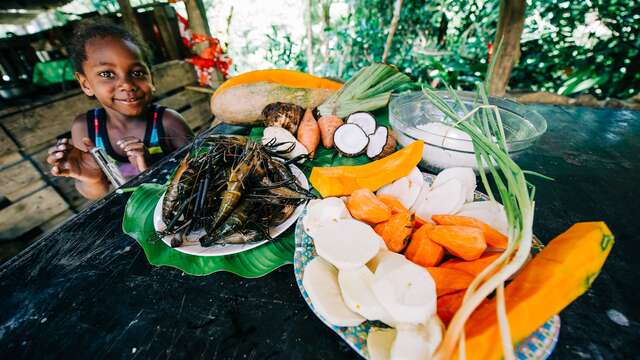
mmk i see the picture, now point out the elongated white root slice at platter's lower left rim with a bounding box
[302,257,365,326]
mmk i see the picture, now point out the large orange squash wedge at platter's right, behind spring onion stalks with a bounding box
[465,222,614,360]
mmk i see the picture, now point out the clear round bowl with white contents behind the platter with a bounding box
[389,91,547,172]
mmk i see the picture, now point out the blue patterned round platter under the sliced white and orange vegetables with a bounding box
[293,173,560,360]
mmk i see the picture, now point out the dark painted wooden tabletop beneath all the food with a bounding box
[0,106,640,359]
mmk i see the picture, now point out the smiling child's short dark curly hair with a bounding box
[68,19,150,73]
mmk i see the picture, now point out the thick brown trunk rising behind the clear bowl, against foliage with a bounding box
[489,0,526,96]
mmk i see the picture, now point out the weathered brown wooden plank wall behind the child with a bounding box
[0,61,212,242]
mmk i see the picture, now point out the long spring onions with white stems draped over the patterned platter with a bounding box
[423,85,537,359]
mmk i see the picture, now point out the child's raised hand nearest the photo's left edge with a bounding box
[47,138,104,182]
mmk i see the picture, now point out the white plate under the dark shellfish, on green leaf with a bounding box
[153,165,309,256]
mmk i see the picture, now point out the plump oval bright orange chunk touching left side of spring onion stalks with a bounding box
[429,225,487,260]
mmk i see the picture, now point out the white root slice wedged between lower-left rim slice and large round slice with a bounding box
[338,266,389,320]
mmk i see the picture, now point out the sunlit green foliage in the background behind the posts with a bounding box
[268,0,640,98]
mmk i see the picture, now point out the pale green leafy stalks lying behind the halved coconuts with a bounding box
[318,64,411,118]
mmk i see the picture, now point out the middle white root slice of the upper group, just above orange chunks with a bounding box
[412,179,466,220]
